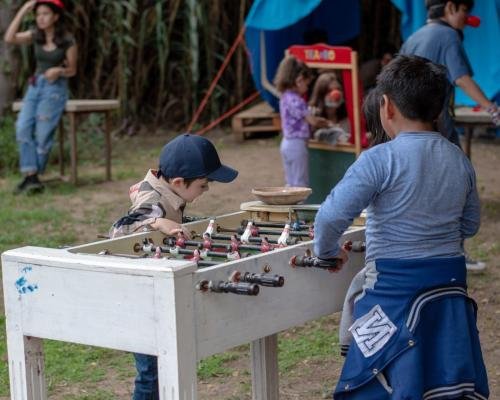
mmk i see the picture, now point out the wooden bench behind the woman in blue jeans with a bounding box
[12,99,120,184]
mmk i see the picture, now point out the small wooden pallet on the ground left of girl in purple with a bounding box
[232,102,281,140]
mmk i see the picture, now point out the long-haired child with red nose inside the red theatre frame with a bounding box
[309,72,351,145]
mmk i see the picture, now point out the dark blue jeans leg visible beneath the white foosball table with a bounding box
[132,353,160,400]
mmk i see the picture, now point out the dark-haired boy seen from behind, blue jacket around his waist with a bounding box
[314,55,489,400]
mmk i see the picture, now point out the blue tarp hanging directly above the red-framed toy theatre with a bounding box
[245,0,361,109]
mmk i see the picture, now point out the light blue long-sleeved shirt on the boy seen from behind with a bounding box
[314,132,480,261]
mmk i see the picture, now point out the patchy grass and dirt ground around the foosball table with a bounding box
[0,128,500,400]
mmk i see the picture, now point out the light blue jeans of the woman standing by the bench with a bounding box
[16,75,68,174]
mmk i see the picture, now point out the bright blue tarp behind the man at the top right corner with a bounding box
[392,0,500,105]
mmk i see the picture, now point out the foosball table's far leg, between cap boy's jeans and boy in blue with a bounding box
[250,334,279,400]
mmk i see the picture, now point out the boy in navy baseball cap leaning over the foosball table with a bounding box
[110,134,238,400]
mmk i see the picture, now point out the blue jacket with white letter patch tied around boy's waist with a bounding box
[334,257,489,400]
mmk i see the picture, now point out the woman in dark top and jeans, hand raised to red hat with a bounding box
[4,0,77,193]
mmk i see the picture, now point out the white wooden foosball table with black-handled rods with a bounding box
[2,212,364,400]
